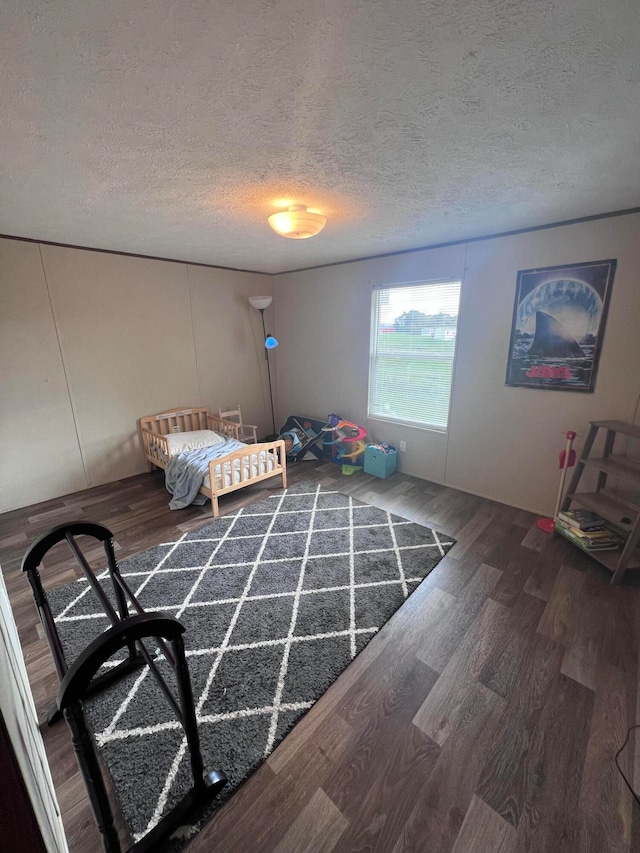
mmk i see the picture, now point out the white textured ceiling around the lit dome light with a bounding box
[0,0,640,272]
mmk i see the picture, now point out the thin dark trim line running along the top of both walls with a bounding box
[0,207,640,276]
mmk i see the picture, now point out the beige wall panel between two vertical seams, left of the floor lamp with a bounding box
[42,246,200,485]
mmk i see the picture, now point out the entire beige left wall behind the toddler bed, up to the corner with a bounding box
[0,240,272,511]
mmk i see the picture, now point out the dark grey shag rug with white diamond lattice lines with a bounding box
[49,482,454,840]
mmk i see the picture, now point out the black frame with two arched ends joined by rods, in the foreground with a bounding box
[22,521,227,853]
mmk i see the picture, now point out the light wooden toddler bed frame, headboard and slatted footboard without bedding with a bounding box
[138,407,287,517]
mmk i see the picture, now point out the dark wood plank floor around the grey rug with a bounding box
[0,462,640,853]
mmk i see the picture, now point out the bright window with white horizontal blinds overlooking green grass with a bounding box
[369,281,461,431]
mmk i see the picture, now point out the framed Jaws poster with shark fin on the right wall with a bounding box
[506,260,616,392]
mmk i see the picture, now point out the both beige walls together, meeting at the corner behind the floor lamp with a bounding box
[5,215,640,513]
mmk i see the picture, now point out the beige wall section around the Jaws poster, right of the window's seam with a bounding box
[447,216,640,512]
